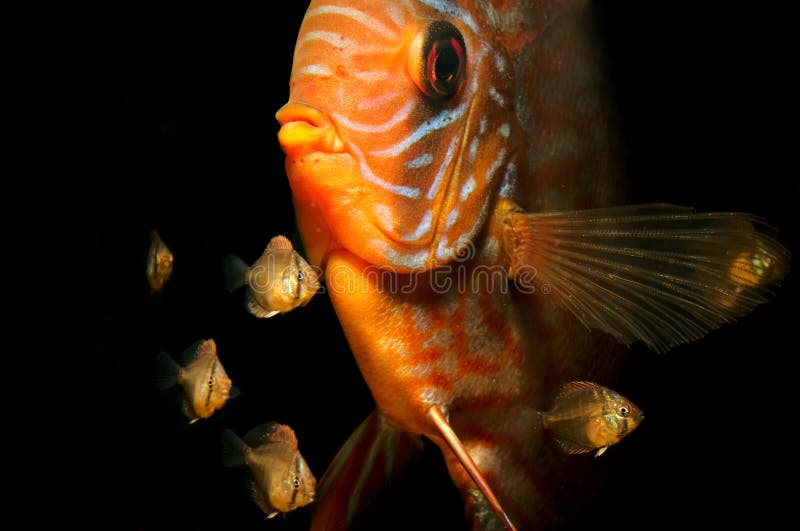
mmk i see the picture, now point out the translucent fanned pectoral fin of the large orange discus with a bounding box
[503,204,789,352]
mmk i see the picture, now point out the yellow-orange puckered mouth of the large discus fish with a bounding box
[275,101,345,157]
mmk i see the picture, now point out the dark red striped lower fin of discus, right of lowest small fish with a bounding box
[311,410,423,531]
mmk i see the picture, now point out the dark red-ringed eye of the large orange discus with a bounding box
[408,21,467,100]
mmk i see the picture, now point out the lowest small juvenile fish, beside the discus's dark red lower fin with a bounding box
[222,422,317,518]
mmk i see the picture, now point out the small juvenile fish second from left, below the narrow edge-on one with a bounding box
[156,339,239,423]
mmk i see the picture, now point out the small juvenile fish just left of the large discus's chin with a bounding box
[225,236,319,318]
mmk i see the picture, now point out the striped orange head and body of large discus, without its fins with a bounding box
[277,0,756,529]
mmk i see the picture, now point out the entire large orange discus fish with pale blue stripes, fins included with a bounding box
[276,0,788,529]
